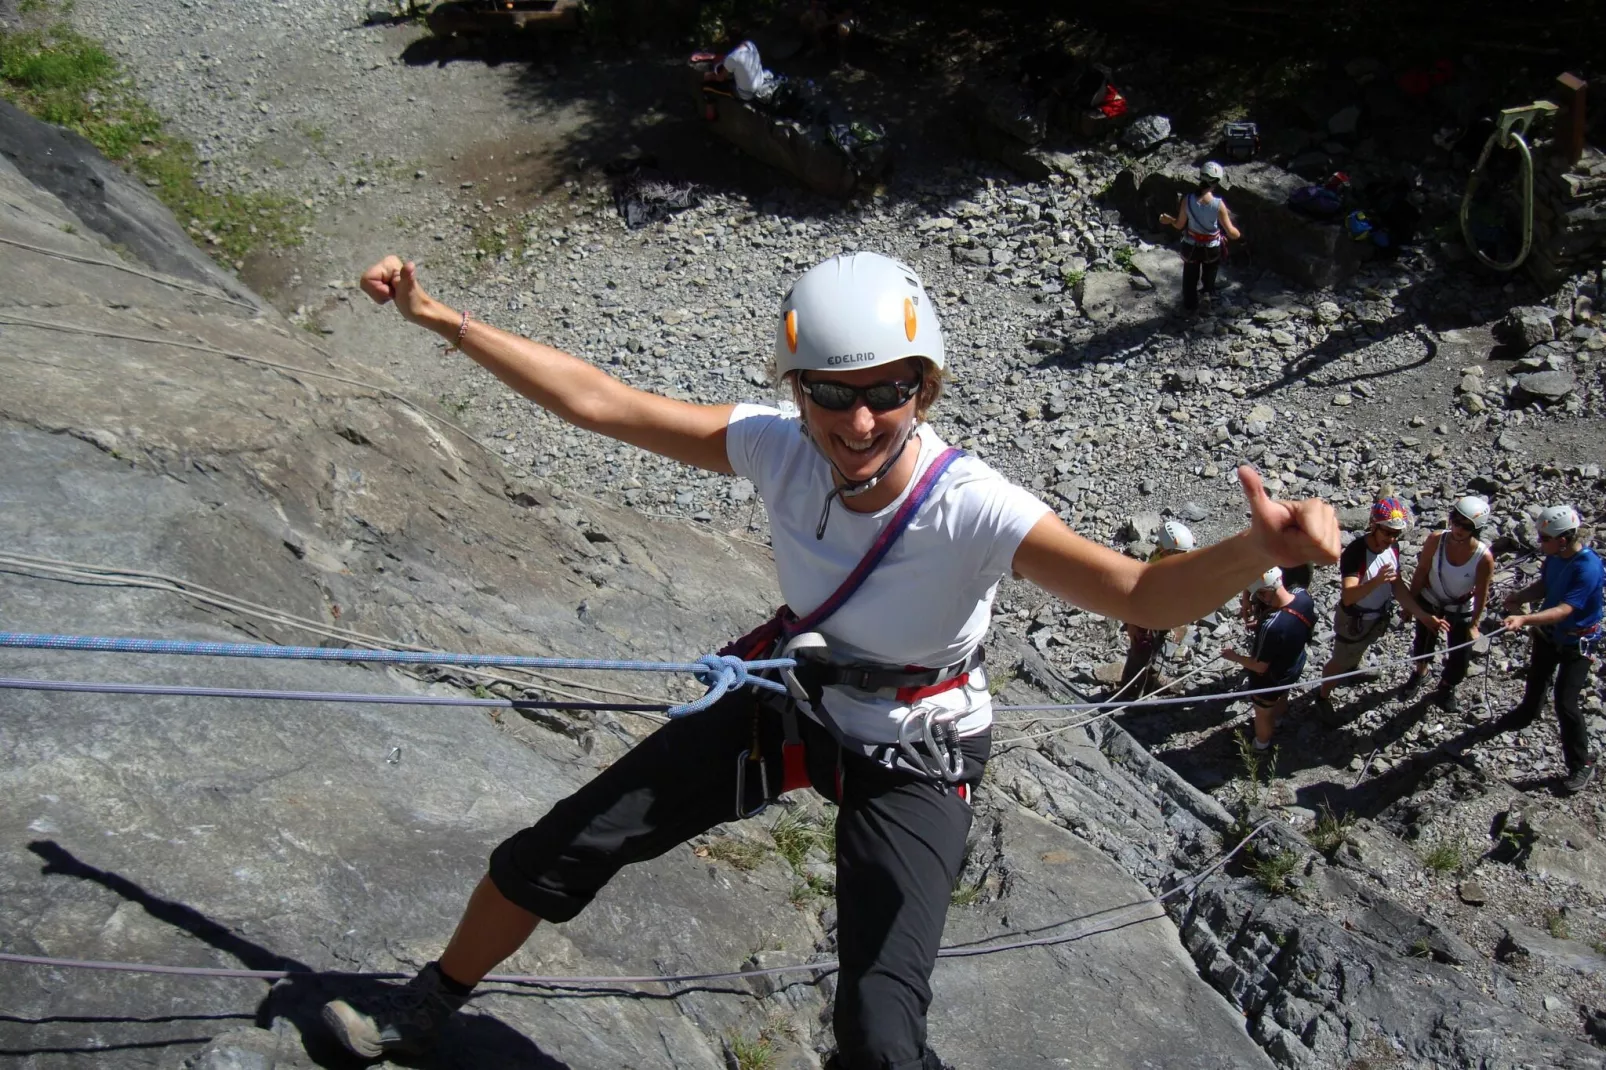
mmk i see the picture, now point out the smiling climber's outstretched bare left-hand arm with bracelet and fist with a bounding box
[361,257,732,474]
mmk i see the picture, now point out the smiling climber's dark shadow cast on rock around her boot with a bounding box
[25,840,569,1070]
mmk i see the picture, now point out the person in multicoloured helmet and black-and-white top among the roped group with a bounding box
[1315,498,1428,717]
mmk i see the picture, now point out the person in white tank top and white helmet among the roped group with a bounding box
[1400,495,1495,713]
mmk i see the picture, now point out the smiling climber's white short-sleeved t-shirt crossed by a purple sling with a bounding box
[726,405,1049,742]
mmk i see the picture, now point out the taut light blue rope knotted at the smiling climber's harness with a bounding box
[0,631,797,717]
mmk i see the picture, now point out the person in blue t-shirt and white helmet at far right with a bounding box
[1497,506,1601,795]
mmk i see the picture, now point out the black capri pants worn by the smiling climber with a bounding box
[490,691,991,1070]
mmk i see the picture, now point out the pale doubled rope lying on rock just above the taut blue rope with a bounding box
[0,551,657,704]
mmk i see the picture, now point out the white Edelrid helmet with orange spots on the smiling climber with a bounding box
[776,252,944,376]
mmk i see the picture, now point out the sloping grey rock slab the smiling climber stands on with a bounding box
[0,104,1270,1070]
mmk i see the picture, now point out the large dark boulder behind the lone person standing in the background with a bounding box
[1108,161,1367,289]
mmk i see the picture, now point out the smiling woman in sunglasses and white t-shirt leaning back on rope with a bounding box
[323,252,1338,1070]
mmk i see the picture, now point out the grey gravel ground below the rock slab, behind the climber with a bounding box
[31,0,1606,1031]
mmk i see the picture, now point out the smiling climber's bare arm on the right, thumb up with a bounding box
[1013,466,1338,631]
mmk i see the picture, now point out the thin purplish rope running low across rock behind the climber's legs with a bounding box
[0,818,1272,988]
